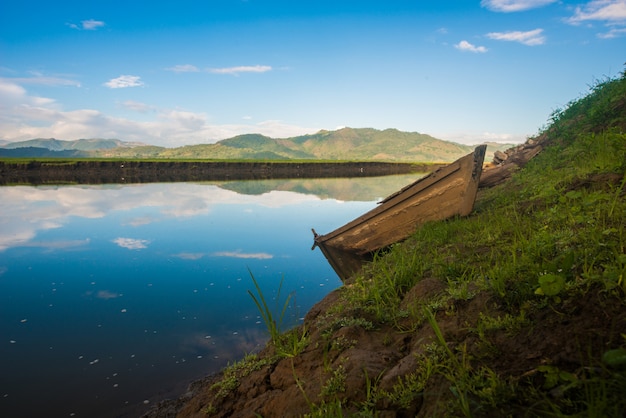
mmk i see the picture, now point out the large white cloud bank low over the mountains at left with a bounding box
[0,78,320,147]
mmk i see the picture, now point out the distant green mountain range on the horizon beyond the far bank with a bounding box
[0,128,515,162]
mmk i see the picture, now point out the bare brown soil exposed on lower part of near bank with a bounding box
[140,278,626,418]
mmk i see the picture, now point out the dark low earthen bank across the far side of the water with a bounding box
[0,159,445,185]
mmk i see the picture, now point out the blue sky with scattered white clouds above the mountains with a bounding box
[0,0,626,147]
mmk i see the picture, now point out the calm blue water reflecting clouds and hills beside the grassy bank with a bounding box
[0,175,418,417]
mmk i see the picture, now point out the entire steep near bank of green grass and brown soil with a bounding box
[144,70,626,417]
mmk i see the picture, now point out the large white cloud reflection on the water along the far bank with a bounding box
[0,176,390,251]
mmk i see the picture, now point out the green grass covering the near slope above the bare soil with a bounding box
[312,69,626,417]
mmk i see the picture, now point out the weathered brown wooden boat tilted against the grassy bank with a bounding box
[313,145,487,262]
